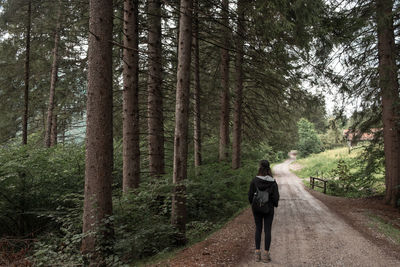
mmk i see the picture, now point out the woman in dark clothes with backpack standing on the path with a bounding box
[249,160,279,262]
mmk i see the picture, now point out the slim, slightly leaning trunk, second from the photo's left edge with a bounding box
[44,1,61,147]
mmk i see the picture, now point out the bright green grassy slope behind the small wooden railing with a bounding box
[294,146,384,197]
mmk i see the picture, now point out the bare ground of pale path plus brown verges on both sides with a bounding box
[154,159,400,267]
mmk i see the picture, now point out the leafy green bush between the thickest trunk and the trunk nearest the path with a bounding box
[114,179,175,261]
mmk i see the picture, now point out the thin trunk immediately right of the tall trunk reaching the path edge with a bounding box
[193,0,201,167]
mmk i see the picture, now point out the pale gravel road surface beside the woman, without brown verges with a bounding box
[238,160,400,267]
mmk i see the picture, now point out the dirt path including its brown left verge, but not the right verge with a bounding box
[157,160,400,267]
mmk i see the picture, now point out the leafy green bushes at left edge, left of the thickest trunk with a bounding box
[0,142,84,236]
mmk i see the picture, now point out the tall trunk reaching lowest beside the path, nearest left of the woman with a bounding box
[171,0,192,245]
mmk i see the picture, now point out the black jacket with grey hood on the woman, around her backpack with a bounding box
[248,175,279,207]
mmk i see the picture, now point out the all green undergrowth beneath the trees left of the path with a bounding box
[0,139,286,266]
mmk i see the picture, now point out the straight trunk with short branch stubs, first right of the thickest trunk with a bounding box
[122,0,140,192]
